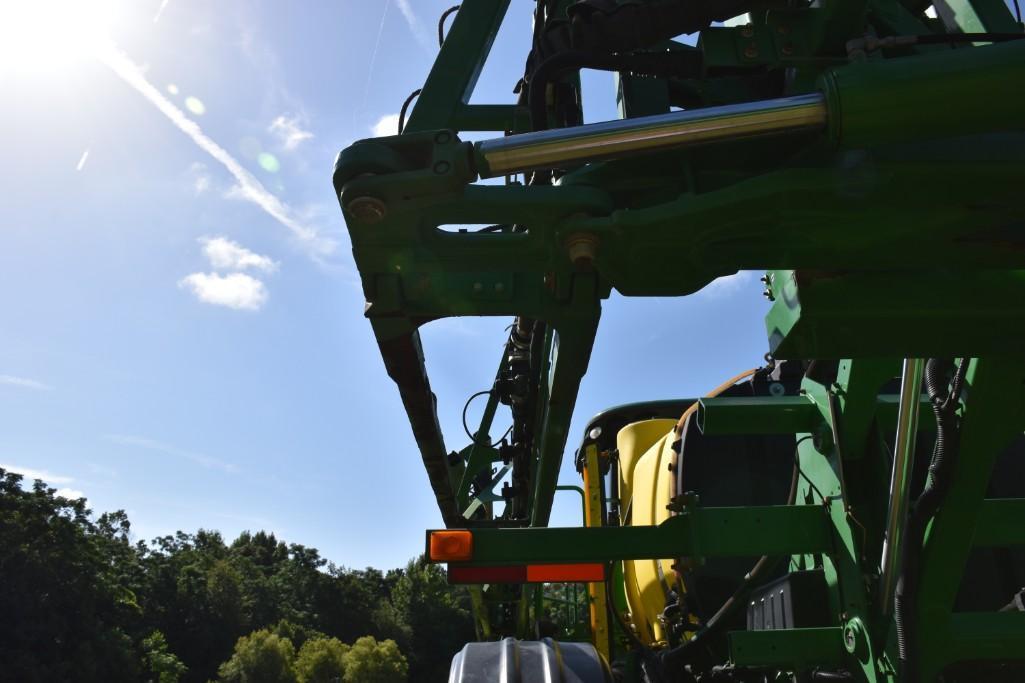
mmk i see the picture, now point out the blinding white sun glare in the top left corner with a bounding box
[0,0,115,78]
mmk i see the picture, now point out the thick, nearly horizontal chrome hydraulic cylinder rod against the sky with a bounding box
[476,92,827,177]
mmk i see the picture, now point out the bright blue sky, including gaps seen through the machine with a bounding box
[0,0,767,568]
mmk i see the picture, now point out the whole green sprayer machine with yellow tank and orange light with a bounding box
[334,0,1025,683]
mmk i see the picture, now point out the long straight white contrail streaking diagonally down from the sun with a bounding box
[97,41,337,256]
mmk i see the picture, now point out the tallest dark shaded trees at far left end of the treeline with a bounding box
[0,469,139,683]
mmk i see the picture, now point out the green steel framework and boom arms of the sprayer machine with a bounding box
[334,0,1025,681]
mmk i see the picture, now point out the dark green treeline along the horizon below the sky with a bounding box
[0,469,474,683]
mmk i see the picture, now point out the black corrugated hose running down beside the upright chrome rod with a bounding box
[894,358,968,683]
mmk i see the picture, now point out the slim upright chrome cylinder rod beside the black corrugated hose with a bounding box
[879,358,926,614]
